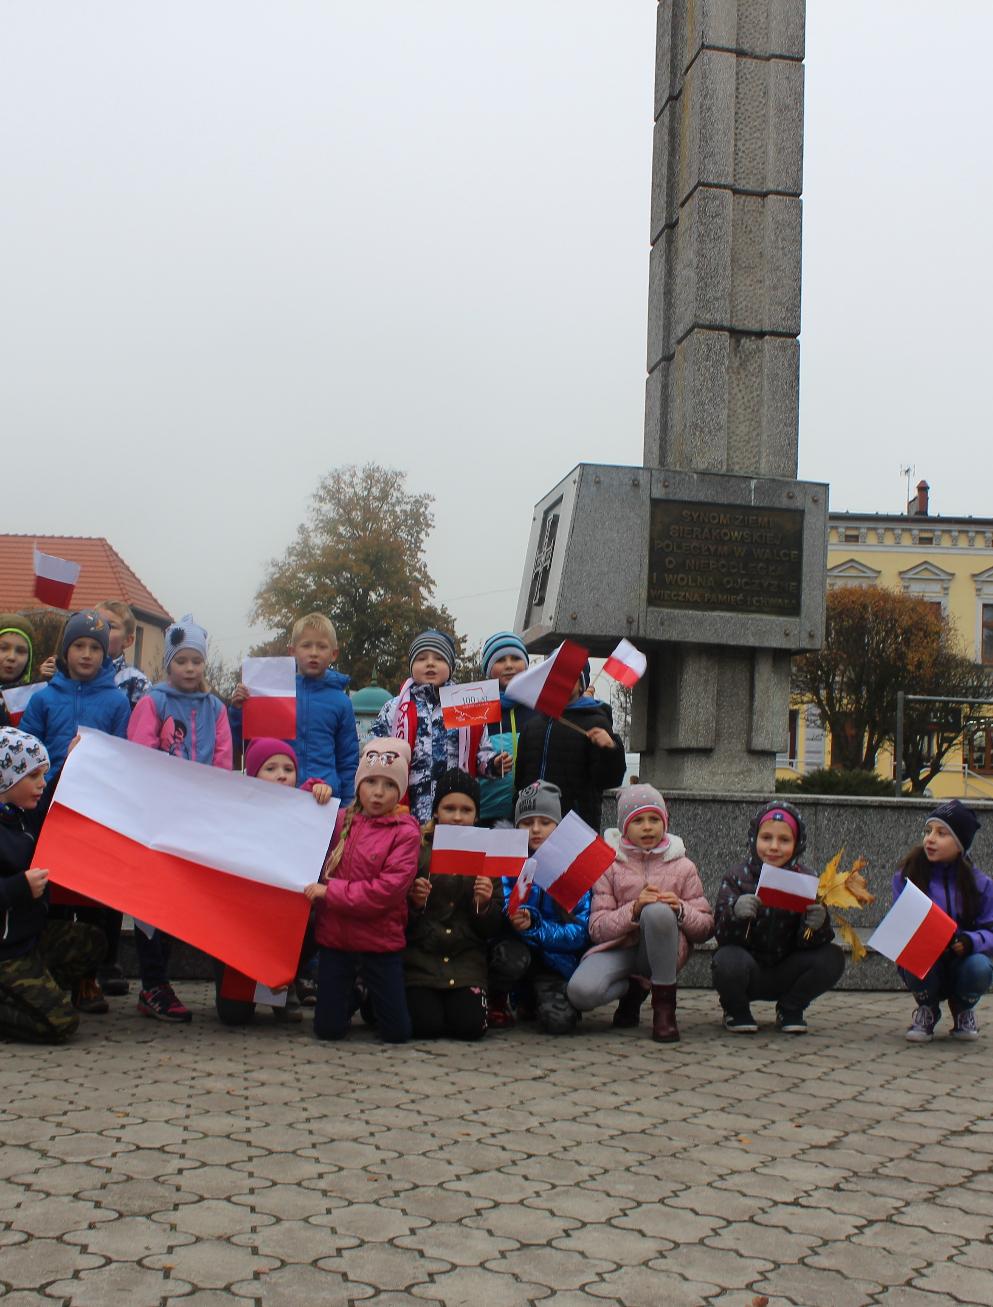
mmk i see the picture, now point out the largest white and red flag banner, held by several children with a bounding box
[34,727,338,988]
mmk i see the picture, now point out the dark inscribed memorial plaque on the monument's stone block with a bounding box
[648,499,804,617]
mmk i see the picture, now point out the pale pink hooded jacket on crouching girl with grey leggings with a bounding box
[587,830,713,970]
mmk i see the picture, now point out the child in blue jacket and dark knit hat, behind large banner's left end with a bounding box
[21,608,131,775]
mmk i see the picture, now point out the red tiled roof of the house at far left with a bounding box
[0,535,172,626]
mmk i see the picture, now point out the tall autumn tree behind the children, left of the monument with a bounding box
[252,463,461,693]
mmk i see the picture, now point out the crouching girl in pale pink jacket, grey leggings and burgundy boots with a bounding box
[567,786,713,1043]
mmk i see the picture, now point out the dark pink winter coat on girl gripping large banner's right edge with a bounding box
[315,809,421,953]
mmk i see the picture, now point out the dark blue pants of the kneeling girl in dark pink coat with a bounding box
[314,949,410,1044]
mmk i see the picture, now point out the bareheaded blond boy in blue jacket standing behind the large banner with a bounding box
[229,613,358,808]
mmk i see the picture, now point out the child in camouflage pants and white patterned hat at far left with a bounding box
[0,727,106,1043]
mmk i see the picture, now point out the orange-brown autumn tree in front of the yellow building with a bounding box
[793,586,993,793]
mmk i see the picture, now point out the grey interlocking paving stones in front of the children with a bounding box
[0,983,993,1307]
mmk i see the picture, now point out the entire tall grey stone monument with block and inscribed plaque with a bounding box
[516,0,827,791]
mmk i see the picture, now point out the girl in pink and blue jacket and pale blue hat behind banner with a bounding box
[124,613,231,1022]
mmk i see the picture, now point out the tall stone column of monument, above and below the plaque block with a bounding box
[631,0,813,791]
